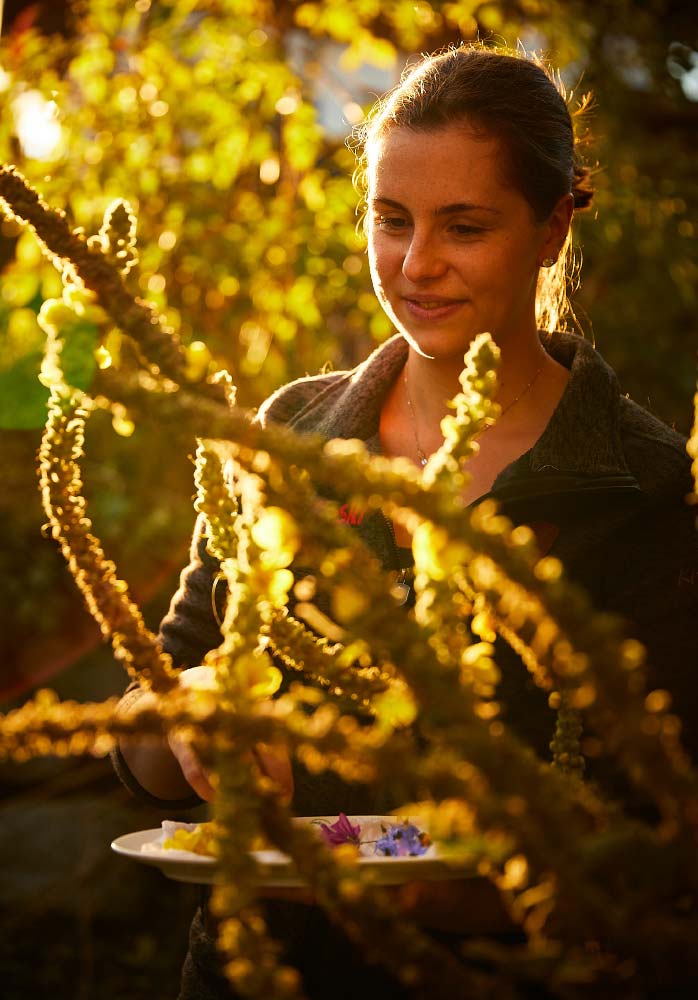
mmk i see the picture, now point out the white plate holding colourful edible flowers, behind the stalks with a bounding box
[111,816,475,888]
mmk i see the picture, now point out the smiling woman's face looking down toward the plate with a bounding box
[368,123,569,364]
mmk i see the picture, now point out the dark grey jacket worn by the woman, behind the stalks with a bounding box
[147,334,698,772]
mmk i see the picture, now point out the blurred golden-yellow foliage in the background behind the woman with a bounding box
[0,0,698,696]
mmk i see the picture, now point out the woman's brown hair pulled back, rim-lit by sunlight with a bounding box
[354,43,594,331]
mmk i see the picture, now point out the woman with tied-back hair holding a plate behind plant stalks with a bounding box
[117,46,698,996]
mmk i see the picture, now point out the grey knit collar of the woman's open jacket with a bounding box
[292,333,628,478]
